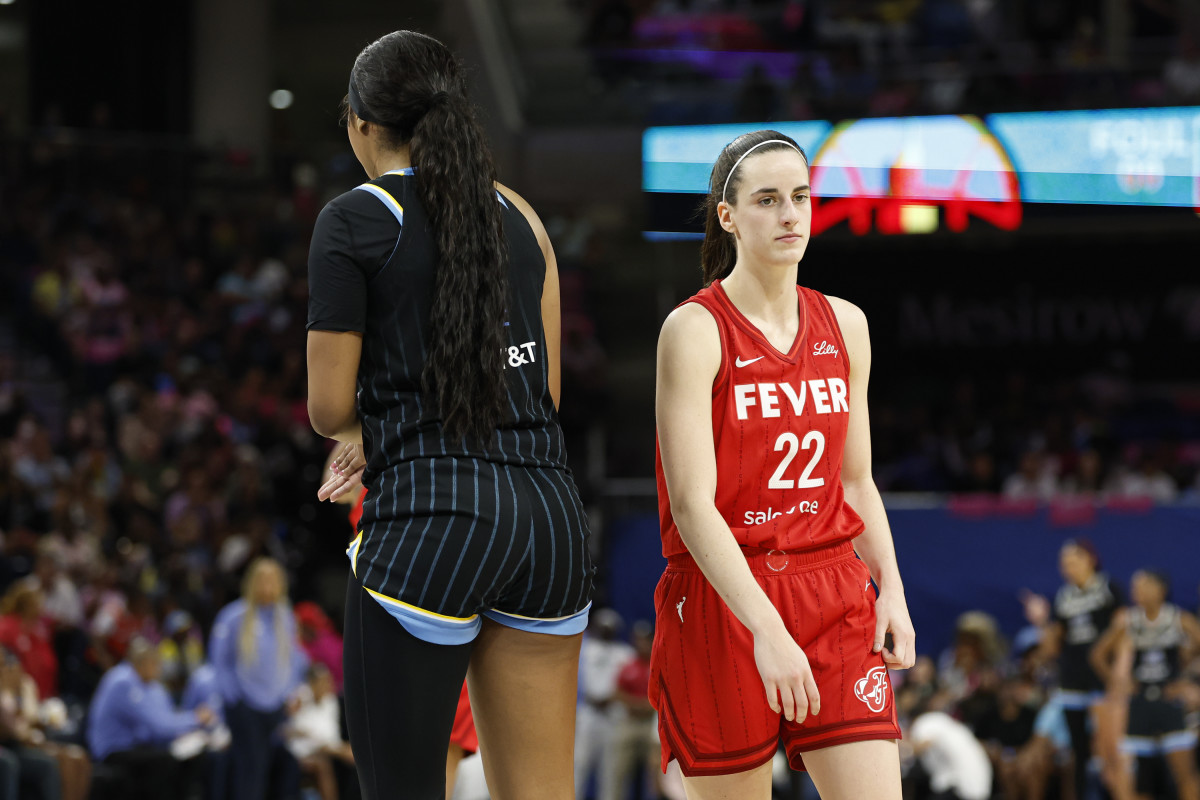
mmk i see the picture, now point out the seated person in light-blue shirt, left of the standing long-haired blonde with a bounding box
[88,639,216,800]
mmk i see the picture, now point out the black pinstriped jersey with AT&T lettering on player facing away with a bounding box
[307,169,566,528]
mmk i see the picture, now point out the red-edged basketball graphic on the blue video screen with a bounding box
[812,116,1021,235]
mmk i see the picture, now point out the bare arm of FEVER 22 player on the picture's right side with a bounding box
[829,297,917,669]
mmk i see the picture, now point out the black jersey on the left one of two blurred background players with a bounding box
[1054,572,1121,691]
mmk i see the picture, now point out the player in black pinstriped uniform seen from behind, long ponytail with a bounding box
[308,31,593,800]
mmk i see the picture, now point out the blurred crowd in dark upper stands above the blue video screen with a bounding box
[578,0,1200,124]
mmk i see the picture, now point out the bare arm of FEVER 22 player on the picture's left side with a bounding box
[655,303,821,721]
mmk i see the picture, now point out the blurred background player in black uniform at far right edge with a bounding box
[1092,570,1200,800]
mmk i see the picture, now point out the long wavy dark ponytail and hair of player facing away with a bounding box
[350,31,509,441]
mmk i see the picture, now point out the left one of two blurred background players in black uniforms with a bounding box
[1042,540,1122,798]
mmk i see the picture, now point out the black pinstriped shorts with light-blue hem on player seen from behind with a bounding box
[347,457,594,644]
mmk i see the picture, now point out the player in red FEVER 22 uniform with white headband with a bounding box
[650,131,914,800]
